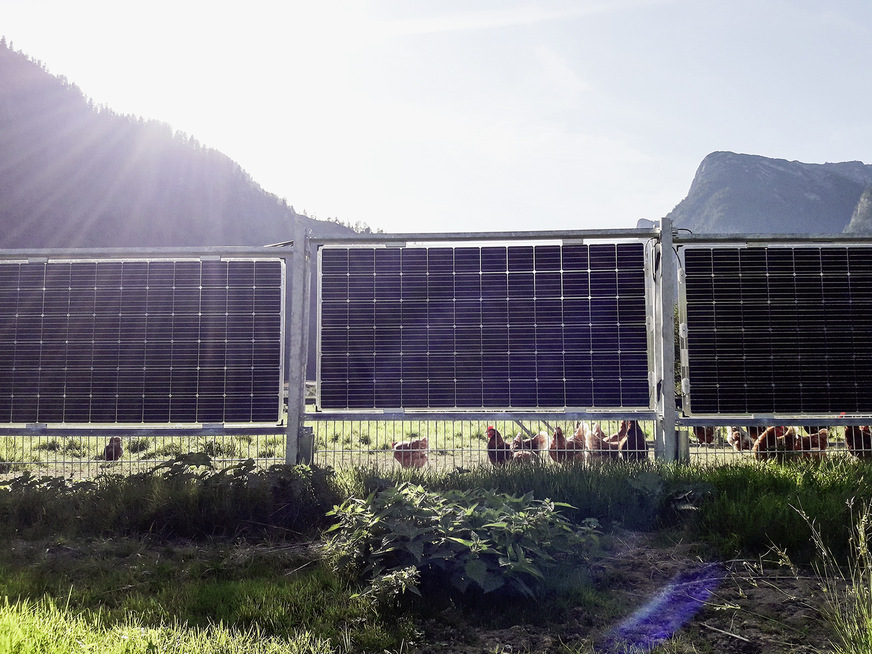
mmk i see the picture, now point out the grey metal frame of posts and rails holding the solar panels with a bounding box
[17,226,872,472]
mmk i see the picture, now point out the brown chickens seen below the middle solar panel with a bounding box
[392,420,648,468]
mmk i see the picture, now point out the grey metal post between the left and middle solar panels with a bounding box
[285,218,309,465]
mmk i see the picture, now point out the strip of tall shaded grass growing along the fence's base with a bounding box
[6,454,872,563]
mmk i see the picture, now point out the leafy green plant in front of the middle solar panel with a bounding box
[327,482,597,597]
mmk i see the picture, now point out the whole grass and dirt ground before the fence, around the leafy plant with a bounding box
[0,456,872,654]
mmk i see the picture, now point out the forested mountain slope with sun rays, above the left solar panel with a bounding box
[0,40,351,248]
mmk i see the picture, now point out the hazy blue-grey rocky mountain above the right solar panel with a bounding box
[668,152,872,234]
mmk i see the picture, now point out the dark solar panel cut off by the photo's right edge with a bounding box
[684,245,872,414]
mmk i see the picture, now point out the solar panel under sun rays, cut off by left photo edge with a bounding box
[0,260,284,423]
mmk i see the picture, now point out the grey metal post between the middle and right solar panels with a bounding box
[654,218,679,462]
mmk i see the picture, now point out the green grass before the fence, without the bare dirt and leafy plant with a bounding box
[0,454,872,654]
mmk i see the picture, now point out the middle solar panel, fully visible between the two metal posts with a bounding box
[318,243,650,409]
